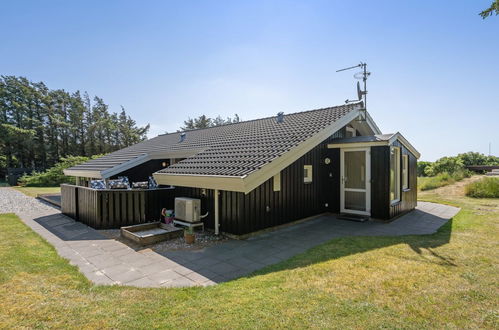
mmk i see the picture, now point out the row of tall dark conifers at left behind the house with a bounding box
[0,76,149,171]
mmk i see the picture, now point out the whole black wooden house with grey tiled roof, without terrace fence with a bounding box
[65,102,420,235]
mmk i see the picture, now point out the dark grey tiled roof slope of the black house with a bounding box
[69,103,362,176]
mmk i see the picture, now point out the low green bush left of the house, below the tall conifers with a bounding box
[19,155,101,187]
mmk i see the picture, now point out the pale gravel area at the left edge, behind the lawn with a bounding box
[0,187,54,215]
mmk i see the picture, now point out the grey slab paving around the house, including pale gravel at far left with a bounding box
[0,188,459,287]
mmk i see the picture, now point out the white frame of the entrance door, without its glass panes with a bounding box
[340,147,371,215]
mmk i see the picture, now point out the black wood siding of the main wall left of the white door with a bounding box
[176,129,345,235]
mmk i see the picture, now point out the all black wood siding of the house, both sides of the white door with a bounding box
[172,130,417,235]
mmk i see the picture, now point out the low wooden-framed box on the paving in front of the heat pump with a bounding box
[121,222,184,245]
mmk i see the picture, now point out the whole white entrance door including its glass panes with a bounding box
[340,148,371,215]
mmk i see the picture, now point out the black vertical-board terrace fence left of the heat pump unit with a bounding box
[61,184,175,229]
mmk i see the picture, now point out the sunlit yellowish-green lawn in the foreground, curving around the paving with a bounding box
[0,188,499,329]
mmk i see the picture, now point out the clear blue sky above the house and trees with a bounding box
[0,0,499,161]
